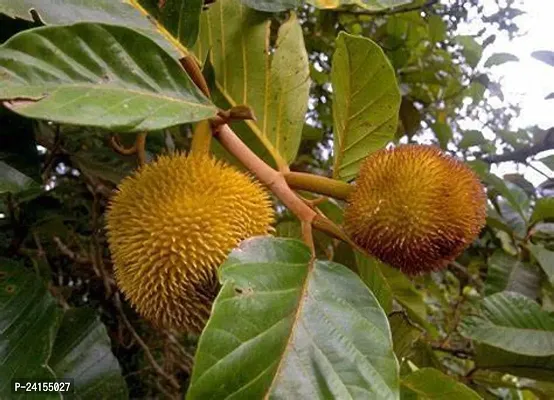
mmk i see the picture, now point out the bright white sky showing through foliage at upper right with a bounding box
[454,0,554,185]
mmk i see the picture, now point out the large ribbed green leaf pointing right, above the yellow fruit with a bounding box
[0,23,217,131]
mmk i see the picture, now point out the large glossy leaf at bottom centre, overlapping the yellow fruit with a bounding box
[187,237,399,399]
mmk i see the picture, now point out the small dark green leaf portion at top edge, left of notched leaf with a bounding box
[137,0,204,47]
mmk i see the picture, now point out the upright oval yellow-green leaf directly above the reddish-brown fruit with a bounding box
[331,32,401,181]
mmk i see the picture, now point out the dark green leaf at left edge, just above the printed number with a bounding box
[0,258,61,398]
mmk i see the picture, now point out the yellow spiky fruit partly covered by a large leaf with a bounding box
[107,154,274,332]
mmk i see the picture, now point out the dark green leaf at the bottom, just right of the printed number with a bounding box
[48,308,128,399]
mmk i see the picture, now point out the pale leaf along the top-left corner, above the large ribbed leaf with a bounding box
[0,0,181,58]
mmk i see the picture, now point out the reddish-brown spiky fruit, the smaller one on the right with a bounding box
[344,145,486,275]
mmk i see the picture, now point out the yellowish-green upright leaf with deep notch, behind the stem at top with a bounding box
[195,0,310,166]
